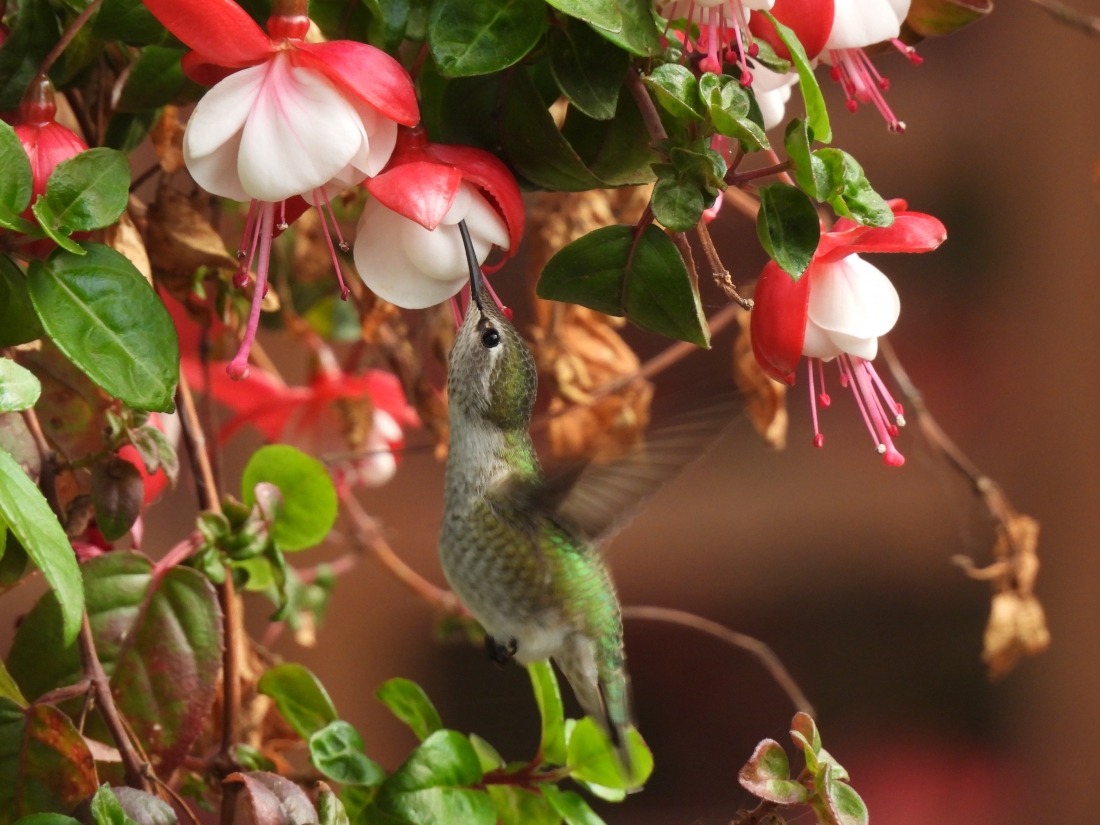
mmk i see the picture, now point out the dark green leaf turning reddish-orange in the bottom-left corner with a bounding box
[0,696,96,825]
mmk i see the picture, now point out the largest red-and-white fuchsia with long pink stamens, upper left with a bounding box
[144,0,420,380]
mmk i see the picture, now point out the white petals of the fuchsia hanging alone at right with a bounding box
[809,255,901,339]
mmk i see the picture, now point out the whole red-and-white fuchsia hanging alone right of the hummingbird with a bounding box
[750,200,947,466]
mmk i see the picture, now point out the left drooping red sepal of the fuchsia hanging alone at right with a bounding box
[749,261,813,384]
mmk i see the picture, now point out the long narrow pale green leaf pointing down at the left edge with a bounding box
[0,450,84,646]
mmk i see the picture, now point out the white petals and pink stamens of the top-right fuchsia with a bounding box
[822,0,923,132]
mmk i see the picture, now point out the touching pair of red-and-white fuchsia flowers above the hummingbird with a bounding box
[145,0,523,380]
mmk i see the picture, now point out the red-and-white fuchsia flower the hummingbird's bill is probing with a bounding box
[354,128,524,309]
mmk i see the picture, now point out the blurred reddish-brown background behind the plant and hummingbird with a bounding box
[8,0,1100,825]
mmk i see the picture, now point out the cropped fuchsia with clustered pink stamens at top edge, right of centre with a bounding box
[657,0,776,86]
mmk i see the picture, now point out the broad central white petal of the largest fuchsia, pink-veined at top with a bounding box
[238,56,363,201]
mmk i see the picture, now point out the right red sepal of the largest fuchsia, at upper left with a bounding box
[294,40,420,127]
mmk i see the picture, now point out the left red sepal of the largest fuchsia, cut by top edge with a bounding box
[144,0,275,68]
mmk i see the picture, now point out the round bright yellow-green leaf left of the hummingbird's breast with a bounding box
[241,444,337,552]
